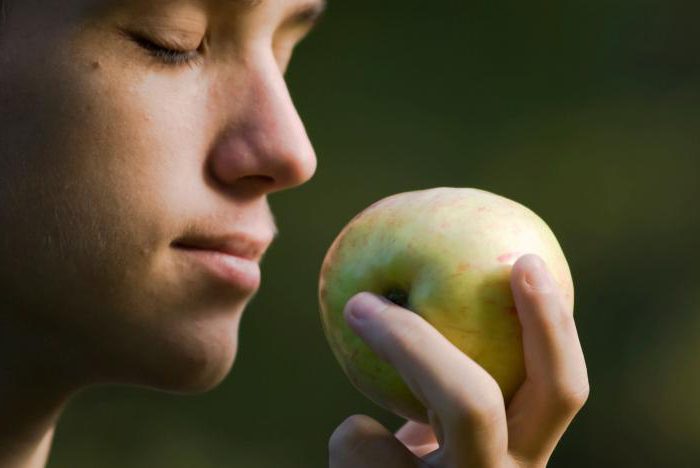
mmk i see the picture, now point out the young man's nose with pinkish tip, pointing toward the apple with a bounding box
[209,54,316,197]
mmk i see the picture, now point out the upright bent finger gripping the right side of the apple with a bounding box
[508,255,589,460]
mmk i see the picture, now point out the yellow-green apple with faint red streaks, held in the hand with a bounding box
[319,187,574,423]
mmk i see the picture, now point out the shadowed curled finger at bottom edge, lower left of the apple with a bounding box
[328,415,425,468]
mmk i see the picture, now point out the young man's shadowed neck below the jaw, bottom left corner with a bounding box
[0,310,82,468]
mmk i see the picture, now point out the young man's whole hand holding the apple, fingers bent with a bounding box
[329,255,589,468]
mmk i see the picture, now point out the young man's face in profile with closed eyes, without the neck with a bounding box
[0,0,321,391]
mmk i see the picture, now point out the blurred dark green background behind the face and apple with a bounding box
[50,0,700,468]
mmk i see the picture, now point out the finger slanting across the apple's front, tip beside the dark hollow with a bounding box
[345,293,507,466]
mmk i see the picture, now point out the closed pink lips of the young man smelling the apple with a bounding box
[171,234,270,294]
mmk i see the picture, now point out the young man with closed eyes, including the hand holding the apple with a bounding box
[0,0,588,468]
